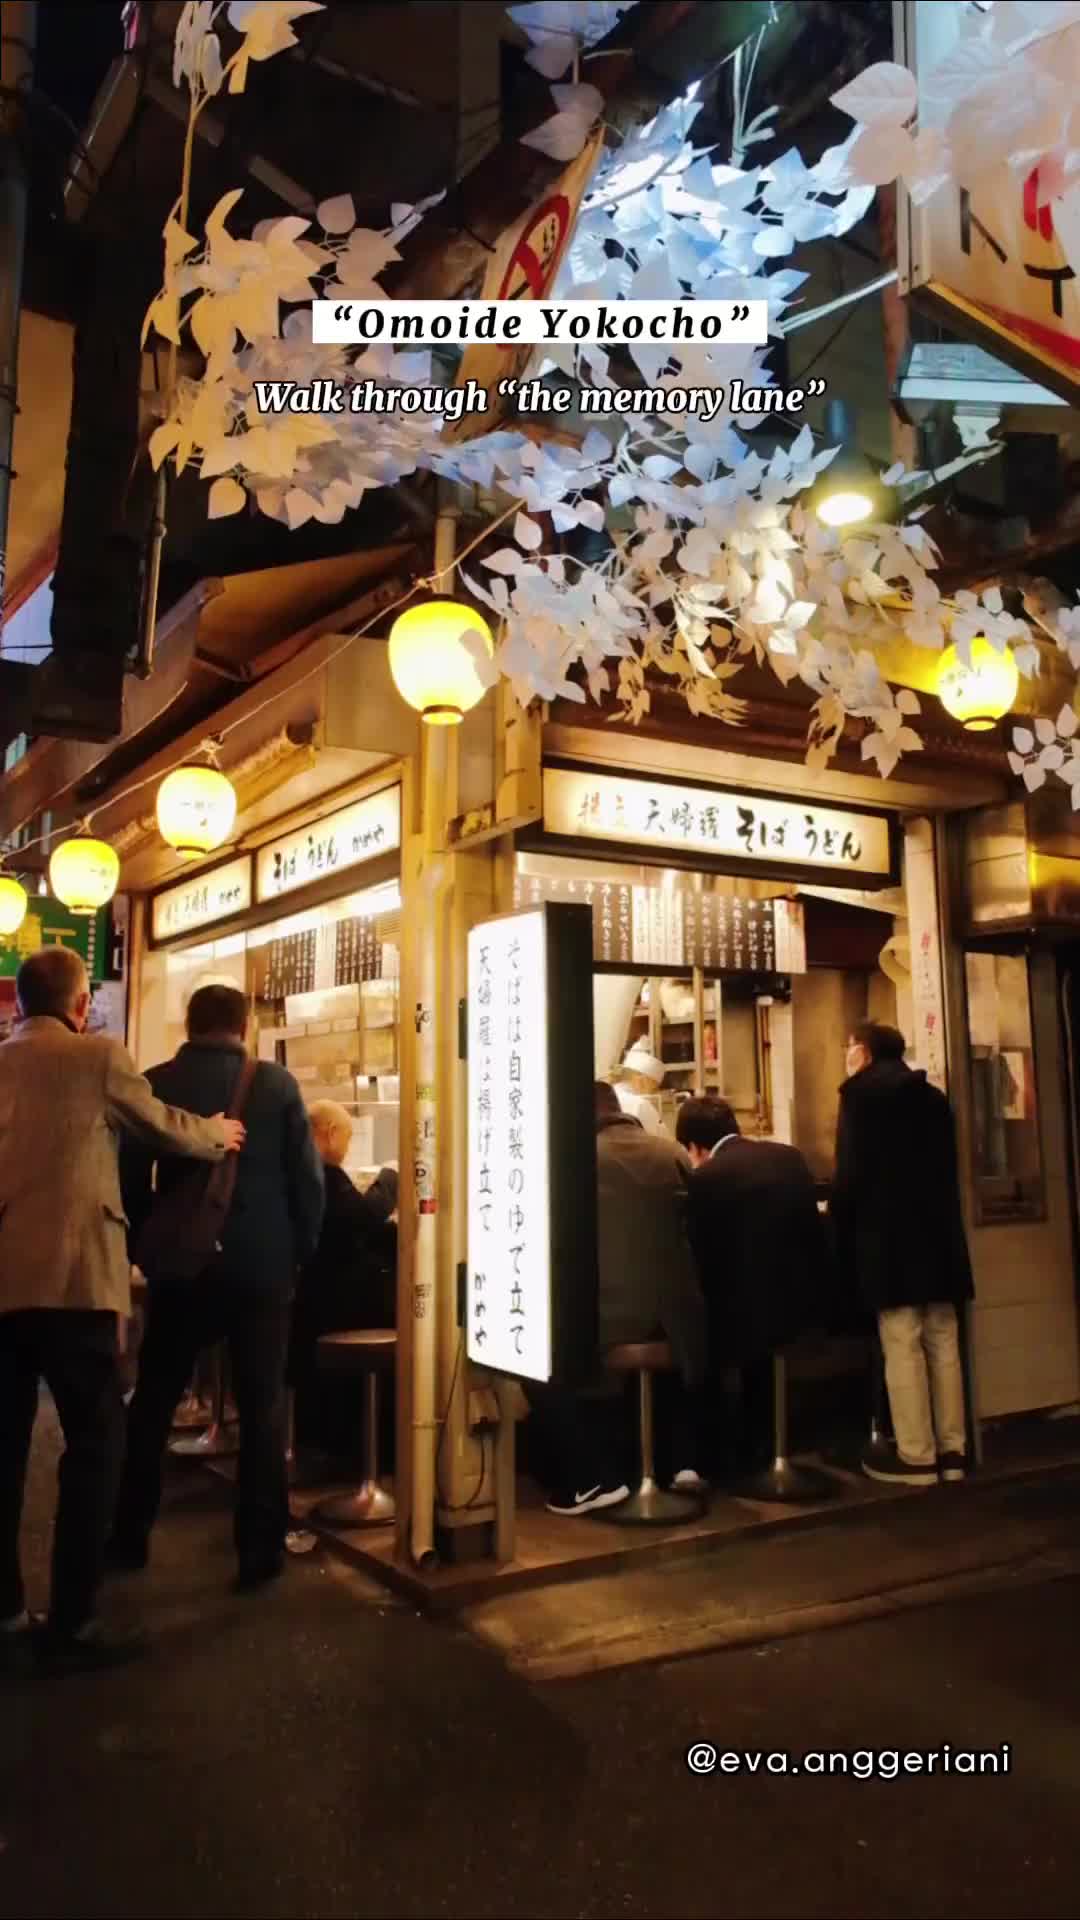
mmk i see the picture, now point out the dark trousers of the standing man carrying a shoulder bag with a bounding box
[115,1271,288,1565]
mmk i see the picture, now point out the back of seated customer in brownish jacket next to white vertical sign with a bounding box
[596,1112,703,1380]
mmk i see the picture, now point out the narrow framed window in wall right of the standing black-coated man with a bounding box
[965,952,1045,1227]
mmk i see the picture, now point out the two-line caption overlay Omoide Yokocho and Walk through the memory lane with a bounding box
[256,300,824,422]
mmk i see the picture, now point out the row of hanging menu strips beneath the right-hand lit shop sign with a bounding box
[513,874,805,973]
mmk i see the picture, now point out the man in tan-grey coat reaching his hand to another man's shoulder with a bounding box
[0,947,244,1665]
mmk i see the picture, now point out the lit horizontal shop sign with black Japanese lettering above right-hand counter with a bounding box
[544,766,892,879]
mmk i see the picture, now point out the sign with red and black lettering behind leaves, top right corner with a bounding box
[896,0,1080,405]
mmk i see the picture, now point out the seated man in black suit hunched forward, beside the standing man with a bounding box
[675,1096,826,1469]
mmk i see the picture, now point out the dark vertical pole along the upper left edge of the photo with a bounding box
[0,0,37,626]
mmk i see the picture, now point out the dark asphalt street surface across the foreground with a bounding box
[0,1430,1080,1920]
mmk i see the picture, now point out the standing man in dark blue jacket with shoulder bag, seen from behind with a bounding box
[111,987,325,1586]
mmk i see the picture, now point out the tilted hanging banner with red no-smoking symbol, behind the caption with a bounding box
[442,129,603,444]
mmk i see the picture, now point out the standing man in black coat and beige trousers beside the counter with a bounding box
[832,1021,974,1486]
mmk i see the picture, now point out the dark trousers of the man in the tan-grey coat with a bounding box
[0,1308,123,1632]
